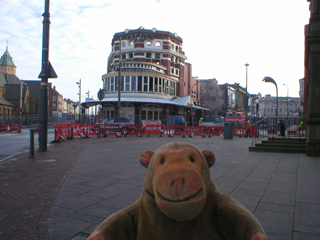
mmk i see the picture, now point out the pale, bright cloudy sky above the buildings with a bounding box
[0,0,310,101]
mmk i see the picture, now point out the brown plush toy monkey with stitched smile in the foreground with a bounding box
[89,143,267,240]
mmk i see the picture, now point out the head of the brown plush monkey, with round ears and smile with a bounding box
[140,143,215,221]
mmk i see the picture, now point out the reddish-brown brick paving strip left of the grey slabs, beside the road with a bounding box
[0,140,92,240]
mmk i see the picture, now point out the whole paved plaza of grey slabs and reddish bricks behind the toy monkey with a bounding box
[0,136,320,240]
